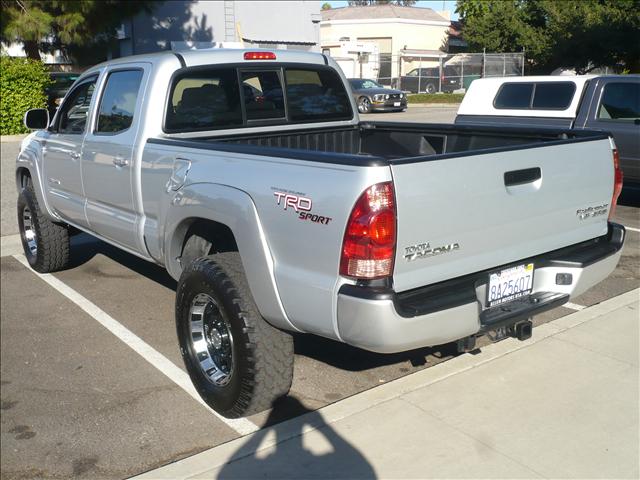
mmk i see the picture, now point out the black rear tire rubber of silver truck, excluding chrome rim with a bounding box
[176,252,294,418]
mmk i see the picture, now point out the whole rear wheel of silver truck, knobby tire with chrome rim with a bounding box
[176,252,294,418]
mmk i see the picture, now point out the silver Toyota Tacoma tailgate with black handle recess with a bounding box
[391,139,614,292]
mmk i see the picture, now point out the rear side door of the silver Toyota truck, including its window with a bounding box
[82,64,148,251]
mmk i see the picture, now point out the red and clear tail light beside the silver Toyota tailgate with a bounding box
[340,182,396,279]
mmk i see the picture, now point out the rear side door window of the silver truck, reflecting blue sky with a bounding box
[96,70,143,133]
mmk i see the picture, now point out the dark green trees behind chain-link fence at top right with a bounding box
[456,0,640,73]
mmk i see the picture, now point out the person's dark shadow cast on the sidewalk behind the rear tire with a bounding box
[212,396,377,480]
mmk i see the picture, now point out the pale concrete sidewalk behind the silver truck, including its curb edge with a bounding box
[132,290,640,480]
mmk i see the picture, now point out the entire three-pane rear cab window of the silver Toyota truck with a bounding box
[164,64,353,133]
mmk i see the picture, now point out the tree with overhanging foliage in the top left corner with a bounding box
[0,0,158,63]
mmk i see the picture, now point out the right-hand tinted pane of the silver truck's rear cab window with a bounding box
[285,69,352,122]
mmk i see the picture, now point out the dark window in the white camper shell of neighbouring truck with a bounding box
[493,82,576,110]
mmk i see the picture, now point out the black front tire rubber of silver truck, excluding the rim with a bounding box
[18,179,69,273]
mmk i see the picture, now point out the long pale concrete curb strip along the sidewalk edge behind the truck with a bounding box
[132,289,640,479]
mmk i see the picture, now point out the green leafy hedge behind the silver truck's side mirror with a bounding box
[0,56,51,135]
